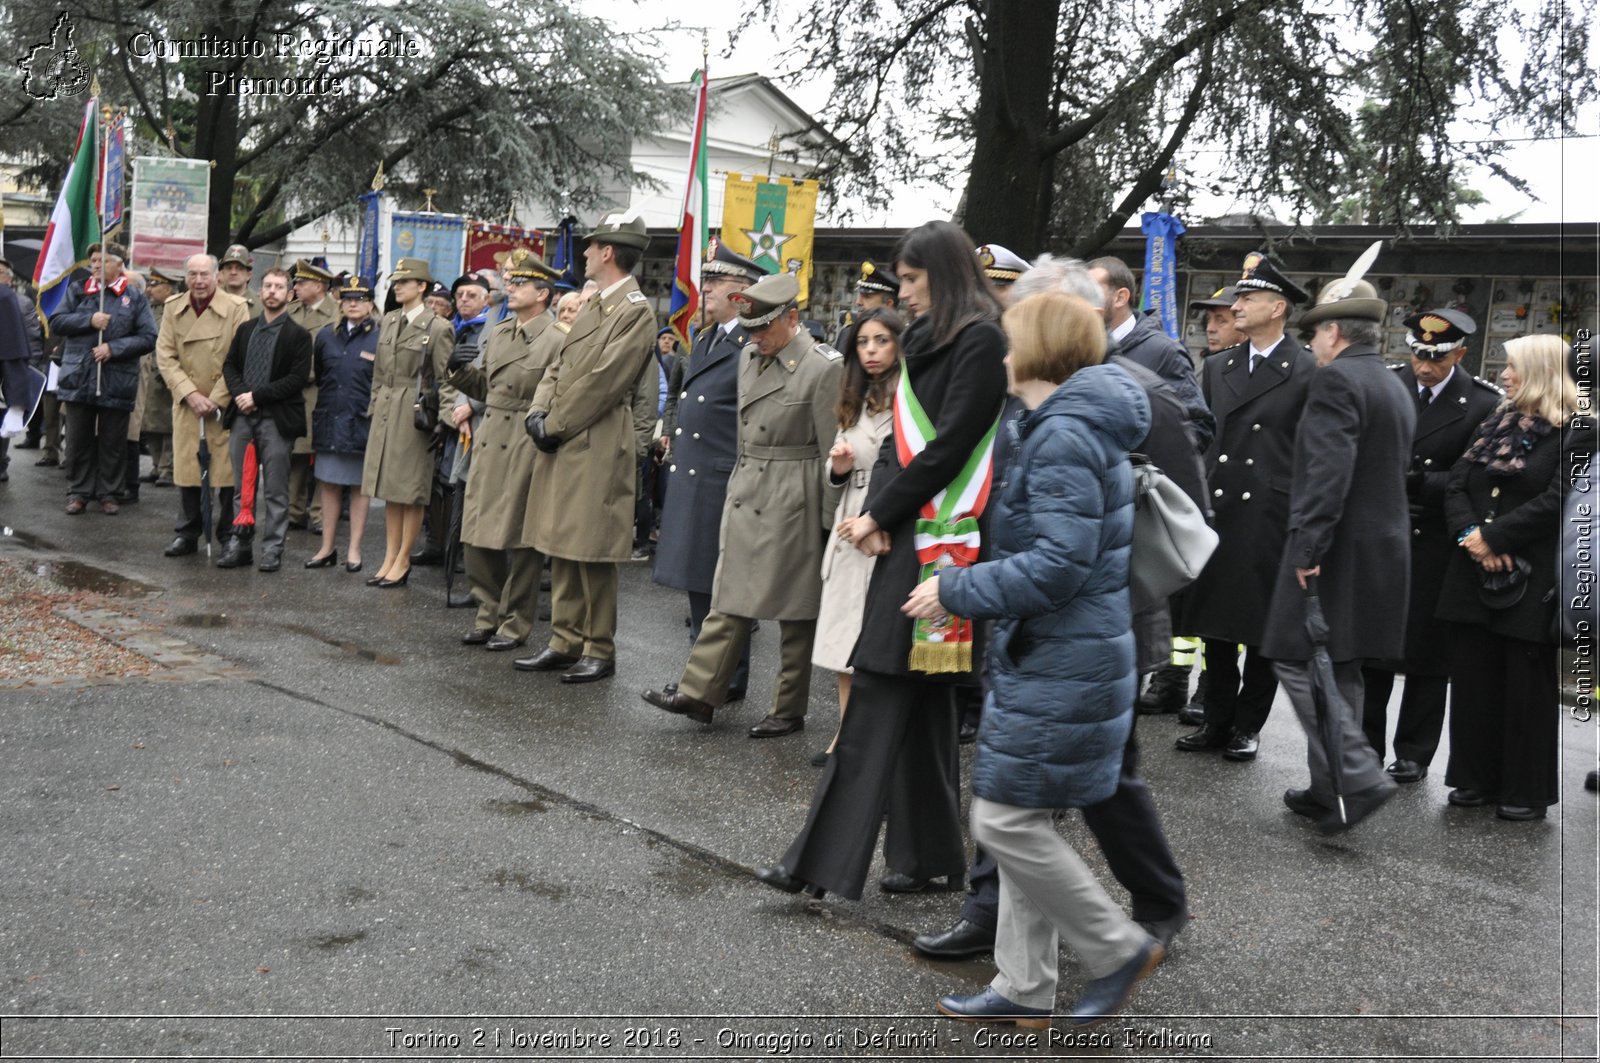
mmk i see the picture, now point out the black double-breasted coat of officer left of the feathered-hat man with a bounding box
[1178,336,1317,645]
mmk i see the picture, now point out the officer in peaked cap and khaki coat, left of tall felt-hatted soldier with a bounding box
[450,248,563,650]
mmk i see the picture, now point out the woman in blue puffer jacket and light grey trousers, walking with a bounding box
[904,293,1162,1028]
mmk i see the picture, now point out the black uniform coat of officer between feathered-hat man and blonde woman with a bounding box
[1373,365,1501,676]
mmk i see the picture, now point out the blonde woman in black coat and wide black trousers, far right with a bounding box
[1438,336,1595,820]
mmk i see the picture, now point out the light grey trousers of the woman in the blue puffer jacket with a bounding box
[973,796,1149,1009]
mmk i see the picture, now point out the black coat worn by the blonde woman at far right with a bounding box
[1438,418,1595,646]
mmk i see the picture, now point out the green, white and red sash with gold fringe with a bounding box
[894,371,1000,672]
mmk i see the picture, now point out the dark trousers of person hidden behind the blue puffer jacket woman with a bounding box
[962,730,1187,929]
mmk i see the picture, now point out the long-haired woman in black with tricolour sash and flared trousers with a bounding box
[757,221,1005,900]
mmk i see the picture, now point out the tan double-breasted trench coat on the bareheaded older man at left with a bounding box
[155,290,250,487]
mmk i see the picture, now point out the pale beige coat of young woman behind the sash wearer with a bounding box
[811,410,894,672]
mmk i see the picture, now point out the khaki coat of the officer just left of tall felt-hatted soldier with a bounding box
[450,314,565,549]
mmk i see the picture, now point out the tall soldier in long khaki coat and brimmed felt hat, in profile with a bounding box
[517,210,656,684]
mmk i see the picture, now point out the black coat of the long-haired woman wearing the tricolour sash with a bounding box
[850,317,1006,682]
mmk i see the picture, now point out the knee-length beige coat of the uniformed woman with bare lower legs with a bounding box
[362,307,456,506]
